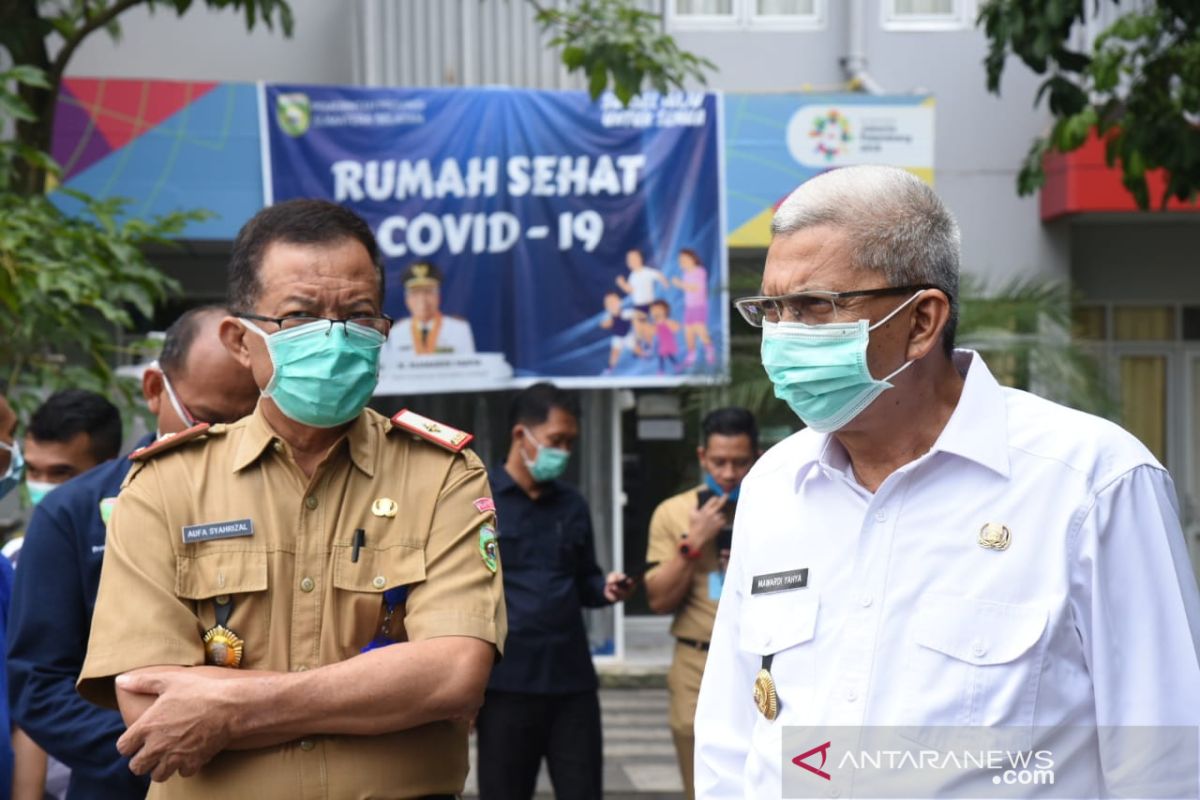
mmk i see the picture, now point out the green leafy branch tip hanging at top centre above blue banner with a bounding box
[529,0,716,106]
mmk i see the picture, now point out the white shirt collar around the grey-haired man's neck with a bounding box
[794,349,1009,489]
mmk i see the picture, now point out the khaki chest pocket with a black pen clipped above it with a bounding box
[331,543,425,658]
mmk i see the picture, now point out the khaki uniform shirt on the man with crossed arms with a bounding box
[79,409,505,800]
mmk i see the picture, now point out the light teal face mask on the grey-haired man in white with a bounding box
[762,291,922,433]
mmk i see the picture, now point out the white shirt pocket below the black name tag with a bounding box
[734,591,821,727]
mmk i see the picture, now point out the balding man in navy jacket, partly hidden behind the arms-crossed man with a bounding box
[8,306,258,800]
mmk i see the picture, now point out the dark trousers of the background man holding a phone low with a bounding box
[475,691,604,800]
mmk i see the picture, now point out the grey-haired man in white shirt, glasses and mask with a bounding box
[696,167,1200,798]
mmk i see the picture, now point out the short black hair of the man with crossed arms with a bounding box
[228,199,384,313]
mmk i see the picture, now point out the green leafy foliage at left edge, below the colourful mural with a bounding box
[0,67,206,413]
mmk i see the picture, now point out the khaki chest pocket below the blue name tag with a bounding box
[175,549,271,669]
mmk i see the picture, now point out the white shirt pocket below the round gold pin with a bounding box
[898,595,1049,748]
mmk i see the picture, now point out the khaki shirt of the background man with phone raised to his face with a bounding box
[646,487,721,642]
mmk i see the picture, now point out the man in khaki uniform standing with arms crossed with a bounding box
[79,200,505,800]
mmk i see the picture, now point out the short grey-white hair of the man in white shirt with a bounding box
[770,166,960,351]
